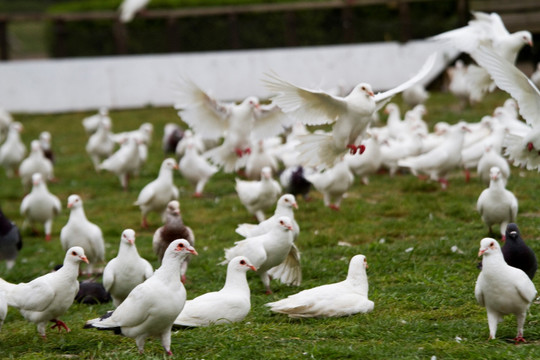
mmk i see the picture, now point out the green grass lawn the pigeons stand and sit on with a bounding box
[0,89,540,359]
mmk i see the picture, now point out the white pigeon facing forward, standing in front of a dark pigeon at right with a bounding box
[474,238,536,344]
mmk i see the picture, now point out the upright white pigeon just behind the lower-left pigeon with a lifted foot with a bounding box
[60,194,105,274]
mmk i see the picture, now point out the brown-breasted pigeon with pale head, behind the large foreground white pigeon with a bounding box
[152,200,195,283]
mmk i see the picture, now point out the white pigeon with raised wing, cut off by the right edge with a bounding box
[475,47,540,169]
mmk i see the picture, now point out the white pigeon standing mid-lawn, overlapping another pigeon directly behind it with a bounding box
[221,216,294,294]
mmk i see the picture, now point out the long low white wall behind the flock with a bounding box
[0,41,457,113]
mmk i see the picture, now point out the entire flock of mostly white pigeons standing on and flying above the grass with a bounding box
[0,8,540,355]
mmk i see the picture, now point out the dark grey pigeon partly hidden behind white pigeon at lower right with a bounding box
[502,223,538,280]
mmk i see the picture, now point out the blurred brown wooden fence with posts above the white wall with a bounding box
[0,0,540,61]
